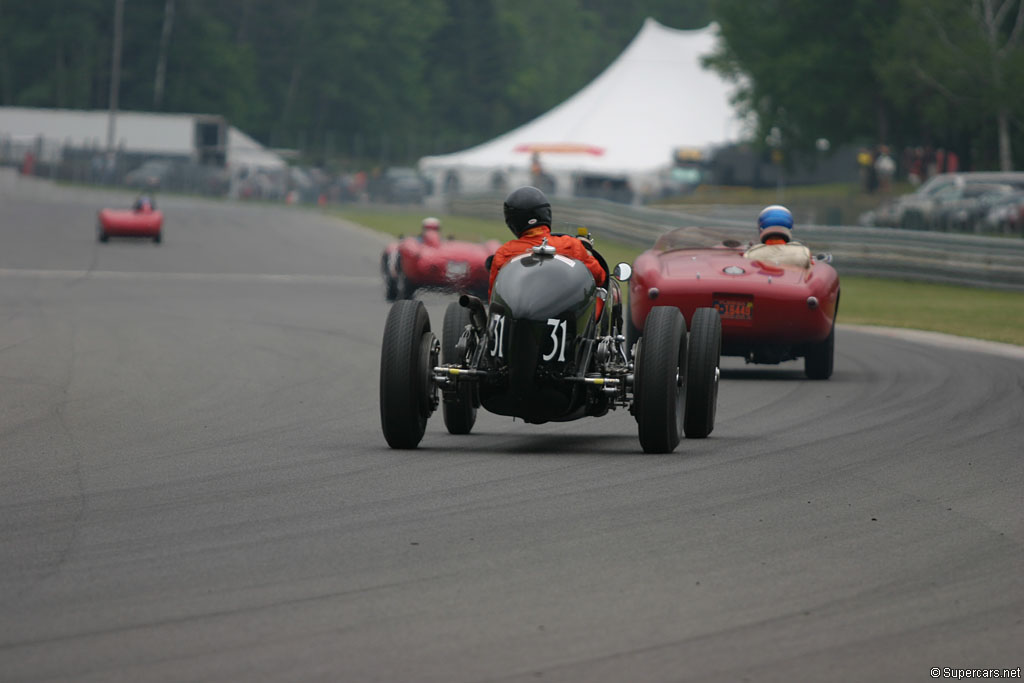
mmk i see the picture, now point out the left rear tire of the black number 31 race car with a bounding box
[380,301,436,449]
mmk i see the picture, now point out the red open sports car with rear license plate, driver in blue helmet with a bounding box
[626,227,840,380]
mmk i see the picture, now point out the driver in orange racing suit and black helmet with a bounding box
[487,185,608,299]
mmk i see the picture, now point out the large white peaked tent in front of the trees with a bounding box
[420,18,740,196]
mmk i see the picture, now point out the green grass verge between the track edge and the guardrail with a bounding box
[334,209,1024,346]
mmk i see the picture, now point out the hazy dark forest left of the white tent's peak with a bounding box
[0,0,710,158]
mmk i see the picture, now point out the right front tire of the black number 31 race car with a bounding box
[683,308,722,438]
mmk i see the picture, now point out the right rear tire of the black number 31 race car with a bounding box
[634,306,686,453]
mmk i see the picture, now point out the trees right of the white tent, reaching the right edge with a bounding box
[708,0,1024,169]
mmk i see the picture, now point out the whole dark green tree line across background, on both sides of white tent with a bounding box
[0,0,1024,168]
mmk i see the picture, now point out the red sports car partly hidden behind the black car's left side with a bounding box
[381,231,501,301]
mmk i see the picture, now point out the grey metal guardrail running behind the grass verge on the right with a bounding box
[447,195,1024,292]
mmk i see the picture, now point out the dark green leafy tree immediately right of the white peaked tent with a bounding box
[706,0,898,154]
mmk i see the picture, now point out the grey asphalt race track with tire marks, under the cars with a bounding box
[0,172,1024,683]
